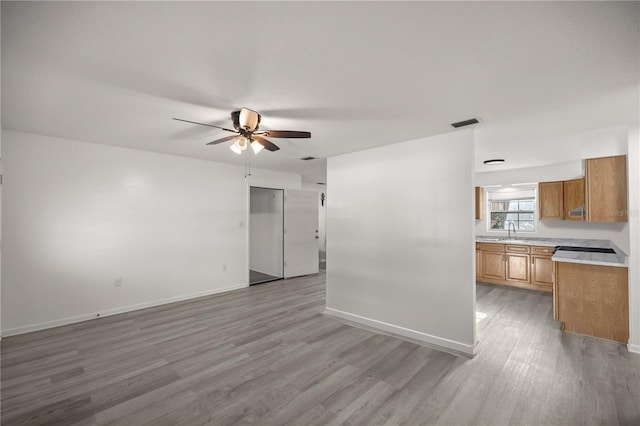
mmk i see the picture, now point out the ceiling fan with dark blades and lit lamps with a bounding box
[174,108,311,154]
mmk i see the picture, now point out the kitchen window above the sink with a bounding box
[487,188,536,232]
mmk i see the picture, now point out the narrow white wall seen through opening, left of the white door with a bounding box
[249,187,284,277]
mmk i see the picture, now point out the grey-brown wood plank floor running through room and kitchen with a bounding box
[1,274,640,425]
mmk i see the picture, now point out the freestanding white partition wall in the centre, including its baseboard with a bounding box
[326,130,475,353]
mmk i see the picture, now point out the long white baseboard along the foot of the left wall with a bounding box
[2,284,248,337]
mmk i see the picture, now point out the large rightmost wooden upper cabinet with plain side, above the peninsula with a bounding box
[586,155,627,222]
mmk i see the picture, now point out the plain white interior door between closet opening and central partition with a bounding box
[284,189,320,278]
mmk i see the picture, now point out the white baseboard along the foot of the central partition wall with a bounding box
[323,308,475,357]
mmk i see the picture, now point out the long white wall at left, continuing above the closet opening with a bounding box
[2,131,301,335]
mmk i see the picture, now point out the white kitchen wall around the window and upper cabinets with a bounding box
[475,127,630,254]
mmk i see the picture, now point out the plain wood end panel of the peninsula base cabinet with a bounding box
[554,262,629,344]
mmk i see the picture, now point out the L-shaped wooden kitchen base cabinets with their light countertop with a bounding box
[476,236,629,344]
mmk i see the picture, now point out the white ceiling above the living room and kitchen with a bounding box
[2,1,640,182]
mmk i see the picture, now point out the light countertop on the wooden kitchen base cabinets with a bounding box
[476,235,628,268]
